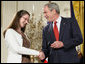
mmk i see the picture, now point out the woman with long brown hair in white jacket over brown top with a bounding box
[3,10,39,63]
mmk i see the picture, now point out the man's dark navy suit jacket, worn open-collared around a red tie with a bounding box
[42,17,83,63]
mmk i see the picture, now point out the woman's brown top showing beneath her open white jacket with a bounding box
[18,32,31,63]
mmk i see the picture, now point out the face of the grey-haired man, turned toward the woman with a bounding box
[44,6,54,22]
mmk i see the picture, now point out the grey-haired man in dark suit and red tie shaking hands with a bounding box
[39,3,83,63]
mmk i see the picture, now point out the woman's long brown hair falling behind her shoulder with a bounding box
[3,10,30,37]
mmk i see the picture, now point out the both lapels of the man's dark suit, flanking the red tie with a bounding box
[48,17,66,41]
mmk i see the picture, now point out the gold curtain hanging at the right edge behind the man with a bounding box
[72,1,84,56]
